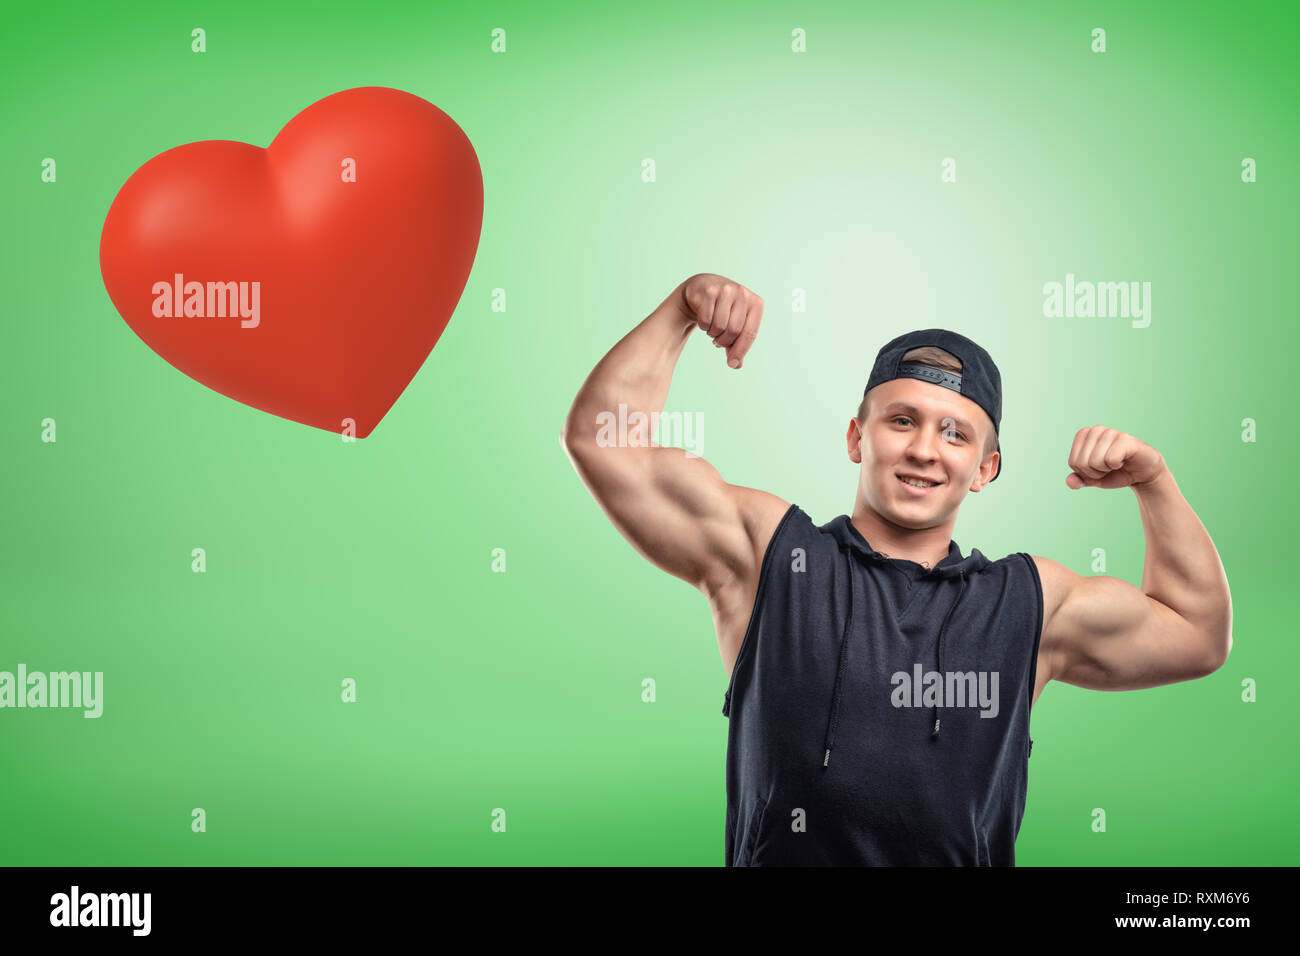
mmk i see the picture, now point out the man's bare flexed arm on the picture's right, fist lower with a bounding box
[1034,425,1232,691]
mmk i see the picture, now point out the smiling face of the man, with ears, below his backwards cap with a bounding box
[849,378,997,528]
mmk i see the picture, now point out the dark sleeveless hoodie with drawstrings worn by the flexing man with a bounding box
[723,505,1043,866]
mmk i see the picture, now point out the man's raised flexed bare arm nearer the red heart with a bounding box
[560,273,789,671]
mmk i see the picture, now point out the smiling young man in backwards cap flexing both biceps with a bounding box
[560,273,1232,866]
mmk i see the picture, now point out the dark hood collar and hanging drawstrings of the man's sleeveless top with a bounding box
[822,515,992,767]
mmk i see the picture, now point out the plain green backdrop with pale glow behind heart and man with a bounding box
[0,3,1300,865]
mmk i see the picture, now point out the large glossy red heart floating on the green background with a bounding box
[99,86,484,438]
